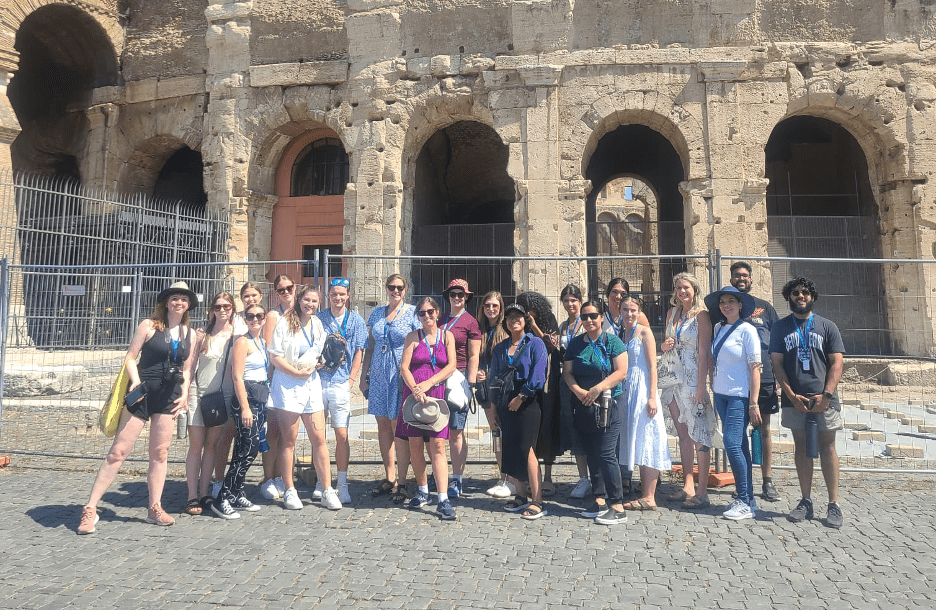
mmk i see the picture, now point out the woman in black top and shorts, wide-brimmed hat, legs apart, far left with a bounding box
[78,282,198,534]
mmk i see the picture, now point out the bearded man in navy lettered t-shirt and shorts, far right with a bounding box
[770,277,845,528]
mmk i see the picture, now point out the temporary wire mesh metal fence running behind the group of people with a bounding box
[0,253,936,474]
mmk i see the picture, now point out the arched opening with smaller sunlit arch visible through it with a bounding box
[585,124,686,326]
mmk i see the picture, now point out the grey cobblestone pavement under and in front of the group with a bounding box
[0,456,936,610]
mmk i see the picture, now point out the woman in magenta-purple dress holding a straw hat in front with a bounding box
[396,297,455,521]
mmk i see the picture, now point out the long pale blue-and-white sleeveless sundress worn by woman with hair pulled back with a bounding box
[618,324,673,470]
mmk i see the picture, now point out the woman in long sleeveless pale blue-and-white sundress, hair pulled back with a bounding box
[618,294,672,510]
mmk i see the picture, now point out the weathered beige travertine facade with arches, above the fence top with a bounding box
[0,0,936,353]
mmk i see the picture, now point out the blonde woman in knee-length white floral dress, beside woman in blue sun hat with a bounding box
[658,273,722,508]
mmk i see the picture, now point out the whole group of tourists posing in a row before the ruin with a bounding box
[78,262,844,534]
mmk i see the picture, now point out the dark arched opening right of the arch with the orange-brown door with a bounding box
[411,121,516,295]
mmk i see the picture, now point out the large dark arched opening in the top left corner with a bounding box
[7,4,118,176]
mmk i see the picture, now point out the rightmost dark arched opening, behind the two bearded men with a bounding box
[764,116,892,354]
